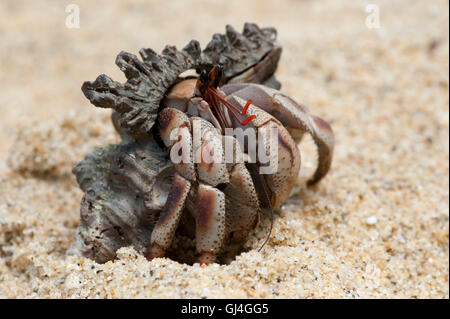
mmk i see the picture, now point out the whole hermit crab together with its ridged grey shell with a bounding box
[69,23,334,264]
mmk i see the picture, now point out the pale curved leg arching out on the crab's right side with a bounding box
[221,83,334,185]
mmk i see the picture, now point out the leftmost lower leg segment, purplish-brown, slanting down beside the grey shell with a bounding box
[147,173,191,260]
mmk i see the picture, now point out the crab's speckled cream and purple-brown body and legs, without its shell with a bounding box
[148,69,333,263]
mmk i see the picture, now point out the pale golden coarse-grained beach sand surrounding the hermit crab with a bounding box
[0,0,449,298]
